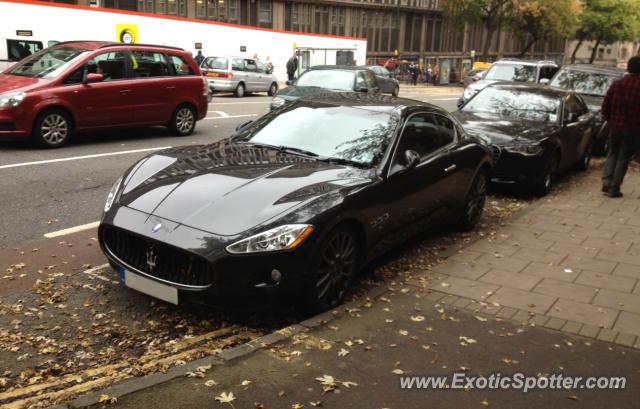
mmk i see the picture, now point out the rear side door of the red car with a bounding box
[130,50,177,125]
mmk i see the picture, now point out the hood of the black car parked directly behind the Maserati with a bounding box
[454,111,559,145]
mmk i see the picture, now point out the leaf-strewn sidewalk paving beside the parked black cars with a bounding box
[79,164,640,409]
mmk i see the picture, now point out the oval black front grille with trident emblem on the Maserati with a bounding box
[102,226,214,287]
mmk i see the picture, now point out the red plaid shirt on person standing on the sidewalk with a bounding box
[602,74,640,131]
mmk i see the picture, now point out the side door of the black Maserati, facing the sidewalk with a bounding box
[387,112,456,227]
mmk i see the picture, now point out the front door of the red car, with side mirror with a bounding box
[59,51,133,129]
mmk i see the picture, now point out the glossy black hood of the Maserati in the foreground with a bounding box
[119,140,371,236]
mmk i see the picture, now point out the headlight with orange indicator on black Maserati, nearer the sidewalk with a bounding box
[227,224,313,254]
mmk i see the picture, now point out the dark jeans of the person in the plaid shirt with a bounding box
[602,130,640,192]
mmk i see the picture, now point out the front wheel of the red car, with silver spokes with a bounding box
[31,109,74,149]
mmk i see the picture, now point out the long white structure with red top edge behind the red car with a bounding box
[0,0,367,81]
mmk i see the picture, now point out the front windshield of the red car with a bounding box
[6,47,89,78]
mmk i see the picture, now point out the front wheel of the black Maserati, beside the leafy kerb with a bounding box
[307,227,358,311]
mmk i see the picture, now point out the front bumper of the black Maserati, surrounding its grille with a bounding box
[98,207,313,305]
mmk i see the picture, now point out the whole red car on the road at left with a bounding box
[0,41,209,148]
